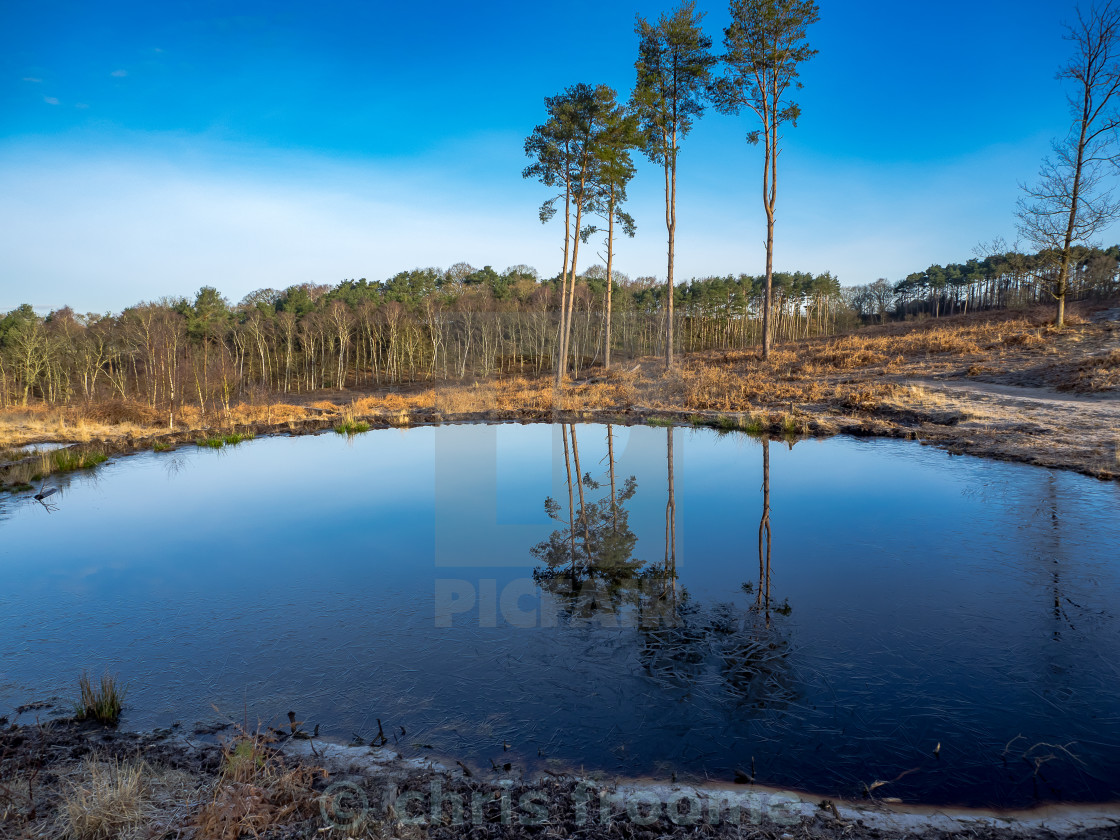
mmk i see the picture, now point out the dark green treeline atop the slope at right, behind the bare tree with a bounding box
[844,245,1120,321]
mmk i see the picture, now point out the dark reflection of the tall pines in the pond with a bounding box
[531,424,797,710]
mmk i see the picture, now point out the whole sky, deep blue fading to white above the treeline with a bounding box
[0,0,1114,311]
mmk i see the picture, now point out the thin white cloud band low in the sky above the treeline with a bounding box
[0,138,1115,311]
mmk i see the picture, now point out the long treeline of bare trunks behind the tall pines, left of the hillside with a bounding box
[0,263,853,422]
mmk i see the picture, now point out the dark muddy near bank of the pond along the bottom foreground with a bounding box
[0,718,1120,840]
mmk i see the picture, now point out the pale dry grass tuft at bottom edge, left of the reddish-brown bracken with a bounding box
[58,758,152,840]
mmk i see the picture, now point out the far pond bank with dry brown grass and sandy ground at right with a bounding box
[0,394,1120,504]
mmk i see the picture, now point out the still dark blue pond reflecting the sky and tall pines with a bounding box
[0,424,1120,806]
